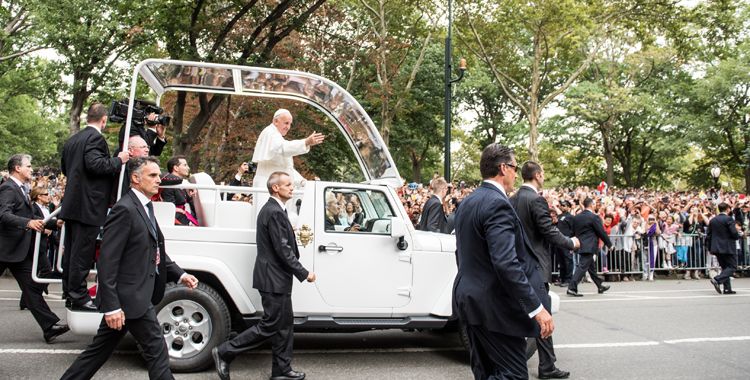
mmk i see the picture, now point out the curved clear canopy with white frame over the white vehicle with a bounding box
[139,60,401,186]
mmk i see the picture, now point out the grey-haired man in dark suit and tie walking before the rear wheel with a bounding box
[62,157,198,380]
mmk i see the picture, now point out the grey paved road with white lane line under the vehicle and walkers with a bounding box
[0,277,750,380]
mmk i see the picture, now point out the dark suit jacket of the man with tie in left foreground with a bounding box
[96,190,185,318]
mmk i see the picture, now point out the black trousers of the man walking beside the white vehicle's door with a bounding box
[218,292,294,376]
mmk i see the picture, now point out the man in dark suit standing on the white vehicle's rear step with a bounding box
[58,103,130,311]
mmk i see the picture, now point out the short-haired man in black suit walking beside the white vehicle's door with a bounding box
[211,172,315,380]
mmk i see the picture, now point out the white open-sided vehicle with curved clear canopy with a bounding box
[32,59,559,371]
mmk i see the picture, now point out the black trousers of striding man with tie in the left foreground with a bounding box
[60,307,174,380]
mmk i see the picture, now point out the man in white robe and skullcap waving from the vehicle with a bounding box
[253,108,325,188]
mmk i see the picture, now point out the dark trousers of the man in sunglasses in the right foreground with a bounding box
[466,325,529,380]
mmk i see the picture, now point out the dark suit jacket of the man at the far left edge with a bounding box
[0,179,34,263]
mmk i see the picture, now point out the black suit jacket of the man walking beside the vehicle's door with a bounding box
[253,197,308,294]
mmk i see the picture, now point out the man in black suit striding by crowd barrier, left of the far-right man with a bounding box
[567,198,612,297]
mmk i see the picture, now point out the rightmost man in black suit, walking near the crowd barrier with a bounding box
[706,202,740,294]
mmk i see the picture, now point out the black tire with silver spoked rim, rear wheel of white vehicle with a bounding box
[156,283,231,372]
